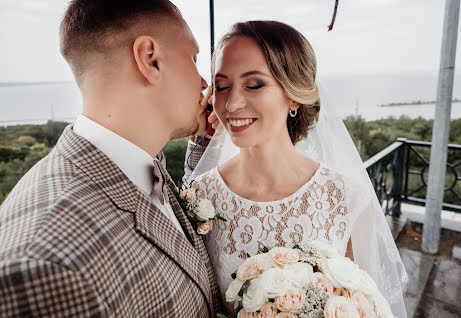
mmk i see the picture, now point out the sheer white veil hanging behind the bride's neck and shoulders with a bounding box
[188,85,408,318]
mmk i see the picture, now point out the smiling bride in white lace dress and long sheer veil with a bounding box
[183,21,407,317]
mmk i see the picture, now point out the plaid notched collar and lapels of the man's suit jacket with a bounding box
[56,125,211,312]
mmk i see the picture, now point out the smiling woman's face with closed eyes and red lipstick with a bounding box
[213,37,290,148]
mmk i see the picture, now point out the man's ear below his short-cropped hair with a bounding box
[133,36,160,85]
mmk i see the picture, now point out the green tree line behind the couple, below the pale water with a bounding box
[0,116,461,203]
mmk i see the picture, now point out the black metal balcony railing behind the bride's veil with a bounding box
[364,138,461,216]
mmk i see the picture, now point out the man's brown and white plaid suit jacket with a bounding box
[0,126,220,317]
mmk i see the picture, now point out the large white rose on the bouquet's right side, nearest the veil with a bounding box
[319,257,362,290]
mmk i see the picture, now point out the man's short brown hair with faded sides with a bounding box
[60,0,184,83]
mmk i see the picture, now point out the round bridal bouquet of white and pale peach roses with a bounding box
[219,241,393,318]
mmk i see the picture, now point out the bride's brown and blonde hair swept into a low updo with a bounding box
[212,21,320,144]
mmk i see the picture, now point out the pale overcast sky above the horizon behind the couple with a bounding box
[0,0,461,82]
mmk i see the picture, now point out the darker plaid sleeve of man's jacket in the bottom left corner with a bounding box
[0,258,107,317]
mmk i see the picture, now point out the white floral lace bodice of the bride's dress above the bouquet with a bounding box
[193,164,352,308]
